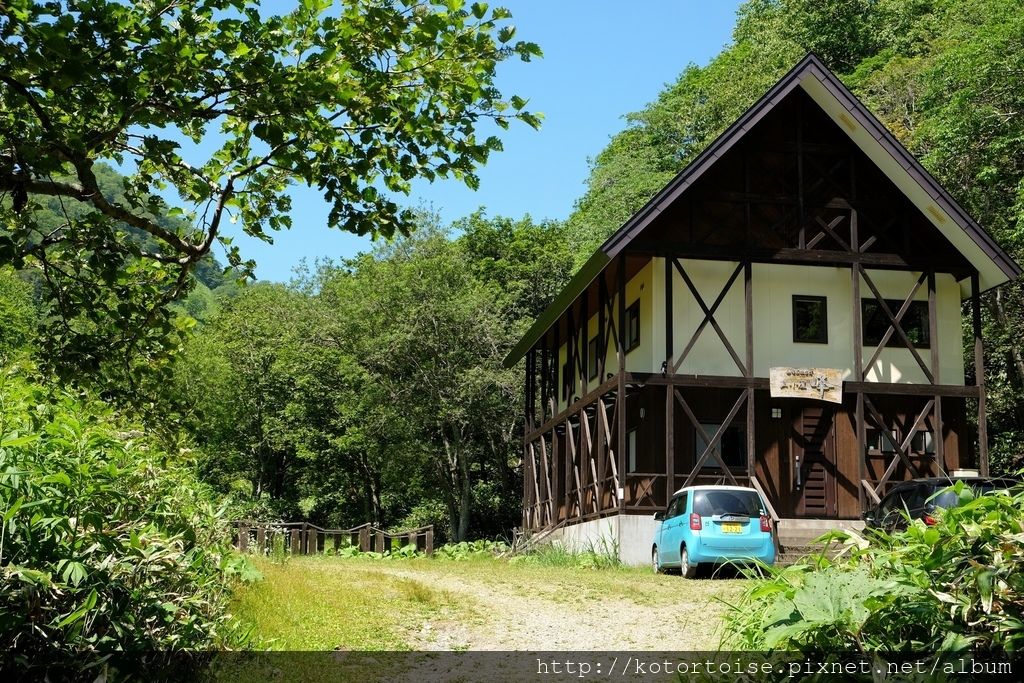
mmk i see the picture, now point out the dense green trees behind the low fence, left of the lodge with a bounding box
[175,213,571,542]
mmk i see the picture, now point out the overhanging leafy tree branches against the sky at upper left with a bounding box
[0,0,540,376]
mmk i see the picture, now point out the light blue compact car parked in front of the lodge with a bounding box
[651,486,775,579]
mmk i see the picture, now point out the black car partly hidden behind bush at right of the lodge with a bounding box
[861,476,1019,530]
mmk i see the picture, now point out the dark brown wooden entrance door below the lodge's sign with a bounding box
[793,403,838,517]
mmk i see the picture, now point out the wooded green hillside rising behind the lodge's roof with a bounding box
[568,0,1024,464]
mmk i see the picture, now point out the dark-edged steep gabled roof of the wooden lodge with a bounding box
[504,53,1021,367]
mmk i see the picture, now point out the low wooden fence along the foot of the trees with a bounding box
[231,520,434,555]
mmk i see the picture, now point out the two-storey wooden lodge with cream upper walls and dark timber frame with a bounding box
[506,55,1020,561]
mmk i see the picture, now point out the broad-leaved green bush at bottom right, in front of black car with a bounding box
[723,482,1024,653]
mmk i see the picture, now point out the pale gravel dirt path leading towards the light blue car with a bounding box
[364,564,739,651]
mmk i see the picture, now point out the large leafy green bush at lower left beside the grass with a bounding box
[0,369,245,678]
